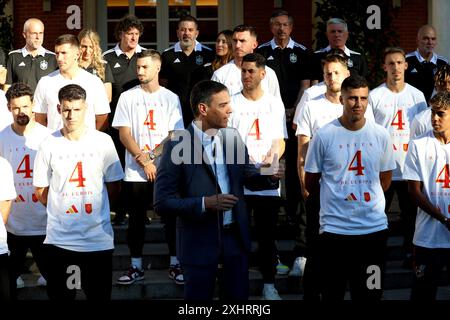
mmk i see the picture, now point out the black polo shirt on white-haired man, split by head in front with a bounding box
[311,46,367,82]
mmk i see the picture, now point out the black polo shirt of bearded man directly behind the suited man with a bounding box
[159,41,214,126]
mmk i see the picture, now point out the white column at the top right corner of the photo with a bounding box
[428,0,450,59]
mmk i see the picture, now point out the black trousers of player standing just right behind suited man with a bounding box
[245,196,280,283]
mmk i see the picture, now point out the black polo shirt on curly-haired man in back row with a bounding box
[103,44,146,114]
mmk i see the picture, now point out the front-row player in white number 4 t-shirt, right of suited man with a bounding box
[305,75,395,301]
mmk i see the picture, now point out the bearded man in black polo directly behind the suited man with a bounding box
[160,15,214,127]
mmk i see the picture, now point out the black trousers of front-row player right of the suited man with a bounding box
[317,229,388,301]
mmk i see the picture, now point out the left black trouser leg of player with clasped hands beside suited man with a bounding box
[124,182,153,258]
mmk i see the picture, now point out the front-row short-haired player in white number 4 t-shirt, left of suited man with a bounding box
[33,84,123,300]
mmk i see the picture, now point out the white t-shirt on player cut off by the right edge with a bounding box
[403,131,450,248]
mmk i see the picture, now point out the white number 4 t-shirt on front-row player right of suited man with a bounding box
[305,119,395,235]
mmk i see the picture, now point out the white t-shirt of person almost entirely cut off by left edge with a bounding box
[0,157,17,254]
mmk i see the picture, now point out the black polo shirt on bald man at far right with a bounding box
[405,50,448,101]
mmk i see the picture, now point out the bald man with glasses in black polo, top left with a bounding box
[4,18,58,92]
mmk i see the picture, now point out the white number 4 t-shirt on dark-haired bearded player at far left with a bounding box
[0,123,50,236]
